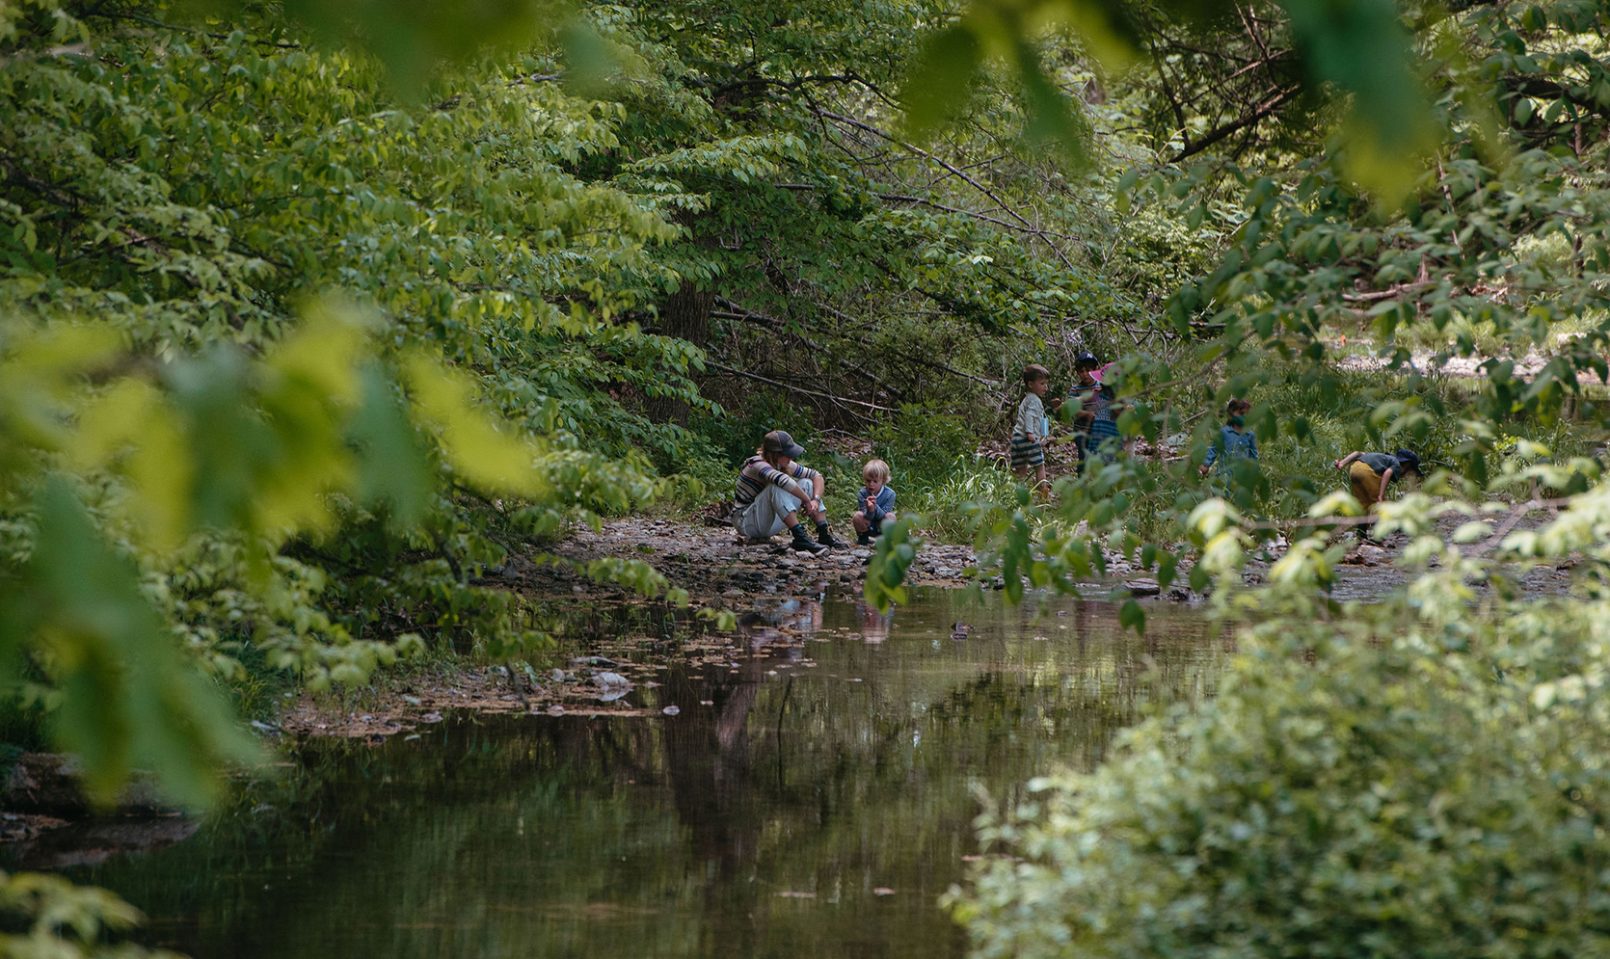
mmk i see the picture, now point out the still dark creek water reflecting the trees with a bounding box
[59,592,1225,959]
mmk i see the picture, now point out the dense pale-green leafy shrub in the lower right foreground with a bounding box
[953,579,1610,959]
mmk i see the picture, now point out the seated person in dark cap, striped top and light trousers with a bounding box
[733,430,844,554]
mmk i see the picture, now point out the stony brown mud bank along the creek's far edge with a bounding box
[276,513,1571,742]
